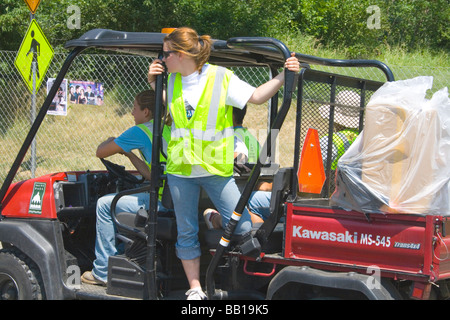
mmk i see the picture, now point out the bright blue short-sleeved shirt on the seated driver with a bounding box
[114,126,152,162]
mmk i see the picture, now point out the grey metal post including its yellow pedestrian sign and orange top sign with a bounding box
[14,0,53,178]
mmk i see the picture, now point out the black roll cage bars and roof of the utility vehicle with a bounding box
[0,29,394,299]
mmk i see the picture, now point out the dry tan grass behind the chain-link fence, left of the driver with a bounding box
[0,98,134,181]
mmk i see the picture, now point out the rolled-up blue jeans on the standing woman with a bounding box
[167,174,252,260]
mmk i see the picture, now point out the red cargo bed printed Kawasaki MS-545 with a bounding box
[283,199,450,282]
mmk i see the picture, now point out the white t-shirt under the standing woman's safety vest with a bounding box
[176,64,256,178]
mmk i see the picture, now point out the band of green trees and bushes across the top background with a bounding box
[0,0,450,53]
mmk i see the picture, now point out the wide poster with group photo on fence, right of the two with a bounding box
[69,80,103,106]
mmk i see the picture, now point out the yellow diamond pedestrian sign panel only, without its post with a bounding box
[14,19,53,92]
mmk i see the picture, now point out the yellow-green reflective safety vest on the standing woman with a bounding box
[167,65,234,176]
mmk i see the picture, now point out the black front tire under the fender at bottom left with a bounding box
[0,248,43,300]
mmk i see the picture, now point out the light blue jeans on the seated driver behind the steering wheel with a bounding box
[92,192,165,282]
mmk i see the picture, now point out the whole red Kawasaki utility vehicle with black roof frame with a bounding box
[0,29,450,299]
